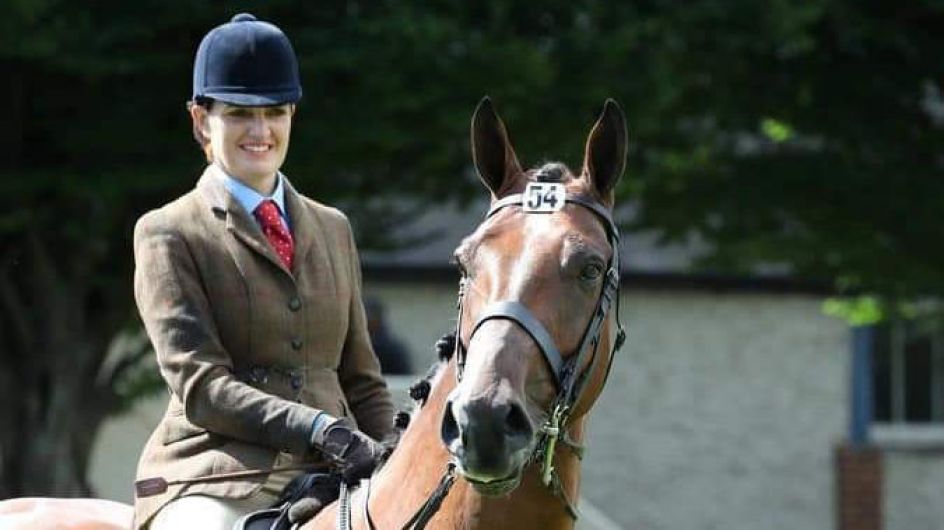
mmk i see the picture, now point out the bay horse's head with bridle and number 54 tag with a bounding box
[442,98,626,495]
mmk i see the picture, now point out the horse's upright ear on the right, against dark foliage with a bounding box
[583,99,627,200]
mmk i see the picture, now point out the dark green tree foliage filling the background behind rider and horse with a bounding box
[0,0,944,497]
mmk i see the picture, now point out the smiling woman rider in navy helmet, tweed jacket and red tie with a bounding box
[134,14,393,530]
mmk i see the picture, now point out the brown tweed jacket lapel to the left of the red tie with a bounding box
[197,165,291,275]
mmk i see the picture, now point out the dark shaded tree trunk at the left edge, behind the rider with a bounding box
[0,230,139,498]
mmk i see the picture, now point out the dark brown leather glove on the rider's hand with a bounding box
[315,418,384,485]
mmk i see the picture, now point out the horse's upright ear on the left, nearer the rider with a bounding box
[472,96,521,197]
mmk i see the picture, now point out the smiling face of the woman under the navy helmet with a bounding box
[191,101,295,186]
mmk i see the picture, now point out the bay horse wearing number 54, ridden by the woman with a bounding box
[0,98,627,530]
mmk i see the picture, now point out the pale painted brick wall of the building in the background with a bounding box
[91,282,944,530]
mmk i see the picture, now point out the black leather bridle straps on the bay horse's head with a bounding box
[455,189,626,519]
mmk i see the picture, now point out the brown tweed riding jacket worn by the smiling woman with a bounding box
[134,166,393,528]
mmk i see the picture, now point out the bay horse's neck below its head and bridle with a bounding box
[304,360,582,530]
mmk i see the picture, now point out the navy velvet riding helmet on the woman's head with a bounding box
[193,13,302,106]
